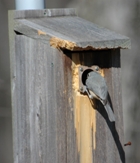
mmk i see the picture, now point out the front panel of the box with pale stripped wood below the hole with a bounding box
[68,49,125,163]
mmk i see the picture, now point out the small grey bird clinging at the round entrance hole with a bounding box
[85,71,115,122]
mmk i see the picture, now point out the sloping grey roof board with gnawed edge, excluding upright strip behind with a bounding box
[15,16,130,50]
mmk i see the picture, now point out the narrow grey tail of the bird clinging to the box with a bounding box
[104,101,115,122]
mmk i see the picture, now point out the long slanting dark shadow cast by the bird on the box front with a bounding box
[91,96,125,163]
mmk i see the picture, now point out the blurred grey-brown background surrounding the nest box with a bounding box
[0,0,140,163]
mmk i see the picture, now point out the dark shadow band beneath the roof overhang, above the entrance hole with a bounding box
[61,49,120,69]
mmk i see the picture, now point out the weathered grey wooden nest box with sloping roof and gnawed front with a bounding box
[9,9,130,163]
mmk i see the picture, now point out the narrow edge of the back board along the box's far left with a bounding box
[8,12,18,163]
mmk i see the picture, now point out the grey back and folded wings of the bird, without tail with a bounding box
[85,71,108,101]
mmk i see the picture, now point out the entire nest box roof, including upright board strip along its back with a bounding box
[10,9,130,50]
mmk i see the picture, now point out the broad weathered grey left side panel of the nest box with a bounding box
[11,35,78,163]
